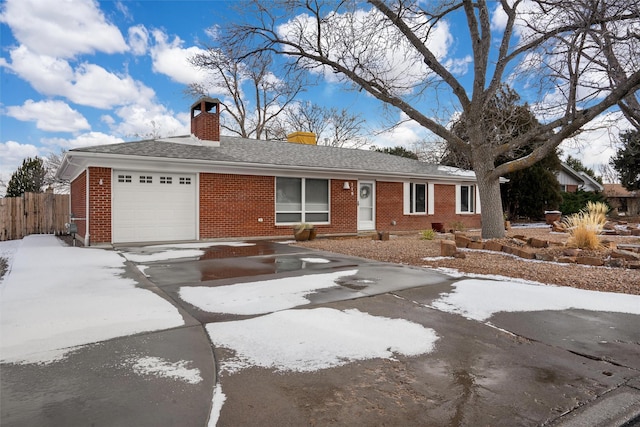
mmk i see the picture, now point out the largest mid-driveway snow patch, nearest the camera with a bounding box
[207,308,438,373]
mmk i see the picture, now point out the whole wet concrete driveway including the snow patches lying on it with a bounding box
[1,241,640,426]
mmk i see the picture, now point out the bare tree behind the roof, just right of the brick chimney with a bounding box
[187,43,304,139]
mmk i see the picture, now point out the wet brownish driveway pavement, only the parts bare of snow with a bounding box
[1,241,640,426]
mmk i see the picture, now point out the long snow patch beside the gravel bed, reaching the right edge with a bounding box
[431,279,640,321]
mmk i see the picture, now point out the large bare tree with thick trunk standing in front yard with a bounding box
[228,0,640,238]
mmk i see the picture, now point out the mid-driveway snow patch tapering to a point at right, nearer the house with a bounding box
[179,270,358,315]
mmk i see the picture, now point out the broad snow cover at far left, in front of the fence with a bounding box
[0,235,184,363]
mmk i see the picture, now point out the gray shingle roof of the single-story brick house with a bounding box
[70,136,475,179]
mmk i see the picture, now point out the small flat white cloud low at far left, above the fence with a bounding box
[7,99,91,132]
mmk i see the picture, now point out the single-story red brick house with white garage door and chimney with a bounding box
[57,98,480,245]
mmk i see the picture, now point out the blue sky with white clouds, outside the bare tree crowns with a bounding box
[0,0,632,191]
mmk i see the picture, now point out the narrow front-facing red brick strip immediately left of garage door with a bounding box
[89,167,111,244]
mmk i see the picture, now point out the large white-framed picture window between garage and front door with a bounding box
[276,177,329,224]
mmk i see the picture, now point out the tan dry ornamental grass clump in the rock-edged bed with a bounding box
[564,202,609,250]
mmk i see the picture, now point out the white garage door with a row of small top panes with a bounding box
[112,171,197,243]
